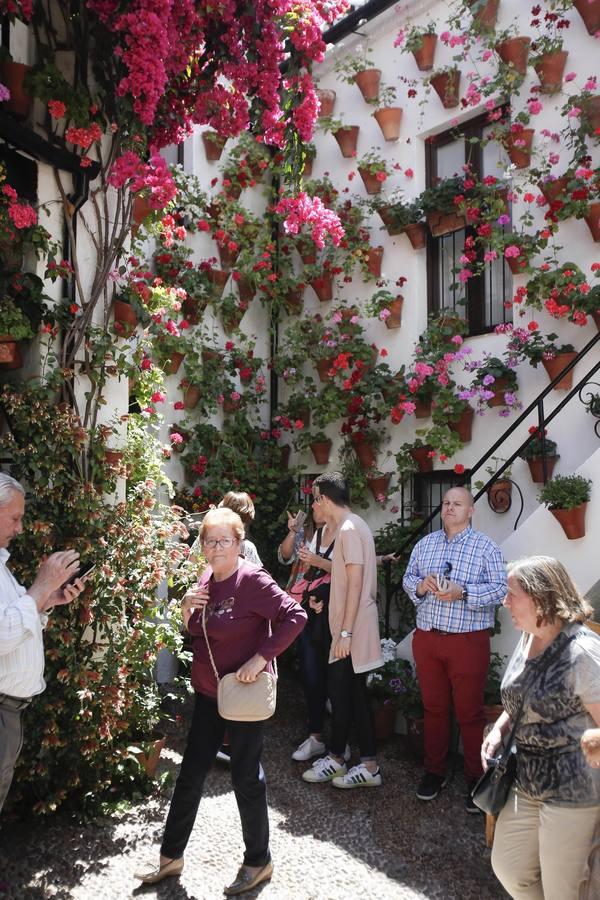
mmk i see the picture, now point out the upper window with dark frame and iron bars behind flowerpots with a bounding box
[426,116,513,334]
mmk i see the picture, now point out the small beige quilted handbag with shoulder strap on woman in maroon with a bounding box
[202,607,277,722]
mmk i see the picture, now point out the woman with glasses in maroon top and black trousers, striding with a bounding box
[137,509,306,895]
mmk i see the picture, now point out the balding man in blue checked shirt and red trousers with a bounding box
[403,488,507,813]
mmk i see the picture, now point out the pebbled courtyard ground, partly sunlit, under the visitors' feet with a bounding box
[0,678,507,900]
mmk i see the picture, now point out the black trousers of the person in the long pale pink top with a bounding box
[329,656,377,760]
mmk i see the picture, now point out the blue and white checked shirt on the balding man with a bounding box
[402,525,507,633]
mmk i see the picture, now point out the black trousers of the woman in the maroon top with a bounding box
[161,694,271,866]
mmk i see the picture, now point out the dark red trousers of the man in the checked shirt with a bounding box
[413,628,490,782]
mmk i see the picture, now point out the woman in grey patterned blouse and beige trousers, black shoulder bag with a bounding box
[482,556,600,900]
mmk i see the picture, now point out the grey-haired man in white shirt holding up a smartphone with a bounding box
[0,473,84,810]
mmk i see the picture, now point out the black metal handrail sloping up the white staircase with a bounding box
[384,332,600,636]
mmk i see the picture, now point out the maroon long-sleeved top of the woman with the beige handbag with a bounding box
[188,562,307,697]
